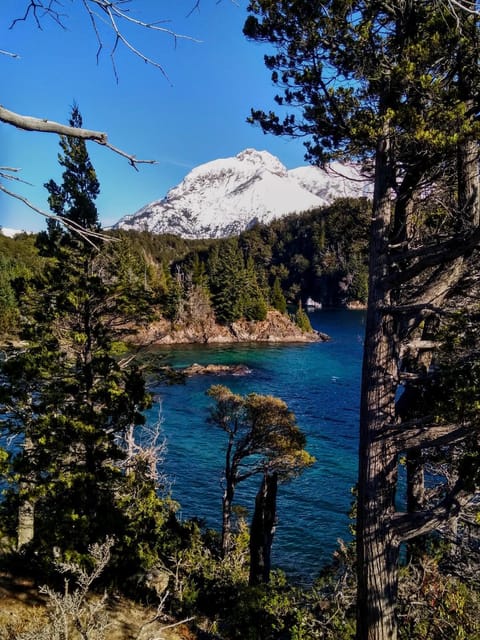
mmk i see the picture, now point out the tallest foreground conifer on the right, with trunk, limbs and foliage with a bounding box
[248,0,480,640]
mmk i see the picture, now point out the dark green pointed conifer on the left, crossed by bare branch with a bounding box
[1,107,167,568]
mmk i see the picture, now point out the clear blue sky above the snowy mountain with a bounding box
[0,0,305,231]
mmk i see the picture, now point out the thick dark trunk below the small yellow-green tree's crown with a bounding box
[249,473,278,585]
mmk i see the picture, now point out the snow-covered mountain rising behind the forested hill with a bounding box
[114,149,371,238]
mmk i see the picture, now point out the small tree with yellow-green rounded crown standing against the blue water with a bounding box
[207,385,315,572]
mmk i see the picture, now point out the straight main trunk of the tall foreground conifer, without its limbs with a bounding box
[357,124,398,640]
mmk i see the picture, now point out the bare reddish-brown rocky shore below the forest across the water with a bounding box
[131,310,329,345]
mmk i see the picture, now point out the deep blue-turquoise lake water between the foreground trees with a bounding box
[145,311,364,580]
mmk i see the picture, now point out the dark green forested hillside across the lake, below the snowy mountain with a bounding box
[0,195,368,341]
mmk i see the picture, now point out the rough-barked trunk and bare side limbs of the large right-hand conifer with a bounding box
[357,81,480,640]
